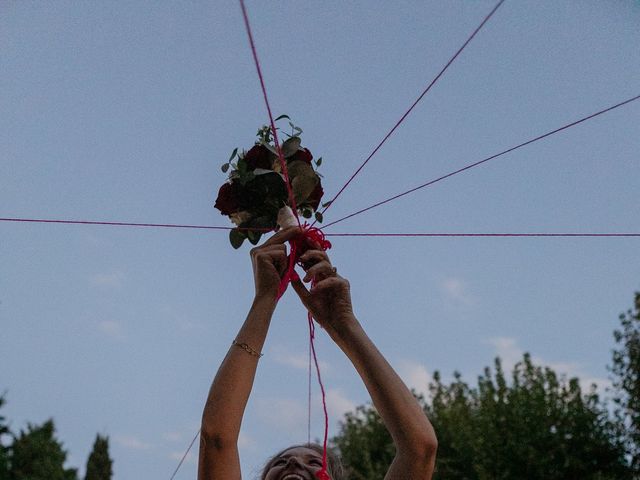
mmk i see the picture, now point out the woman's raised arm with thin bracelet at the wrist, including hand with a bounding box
[198,227,300,480]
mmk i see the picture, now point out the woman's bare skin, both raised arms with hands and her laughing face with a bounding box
[198,227,437,480]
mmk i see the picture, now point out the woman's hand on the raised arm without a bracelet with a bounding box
[291,250,356,338]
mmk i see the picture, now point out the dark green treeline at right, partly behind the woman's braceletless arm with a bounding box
[332,293,640,480]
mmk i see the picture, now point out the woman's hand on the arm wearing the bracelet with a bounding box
[250,227,300,301]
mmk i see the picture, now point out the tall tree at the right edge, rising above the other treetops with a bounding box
[610,292,640,472]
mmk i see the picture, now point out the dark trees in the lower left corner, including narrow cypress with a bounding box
[0,404,113,480]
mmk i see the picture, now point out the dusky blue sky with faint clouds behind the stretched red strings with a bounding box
[0,0,640,480]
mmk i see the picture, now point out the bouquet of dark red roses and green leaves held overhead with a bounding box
[214,115,324,248]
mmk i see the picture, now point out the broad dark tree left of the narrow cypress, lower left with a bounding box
[9,420,78,480]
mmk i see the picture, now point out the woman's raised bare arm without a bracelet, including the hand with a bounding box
[293,250,438,480]
